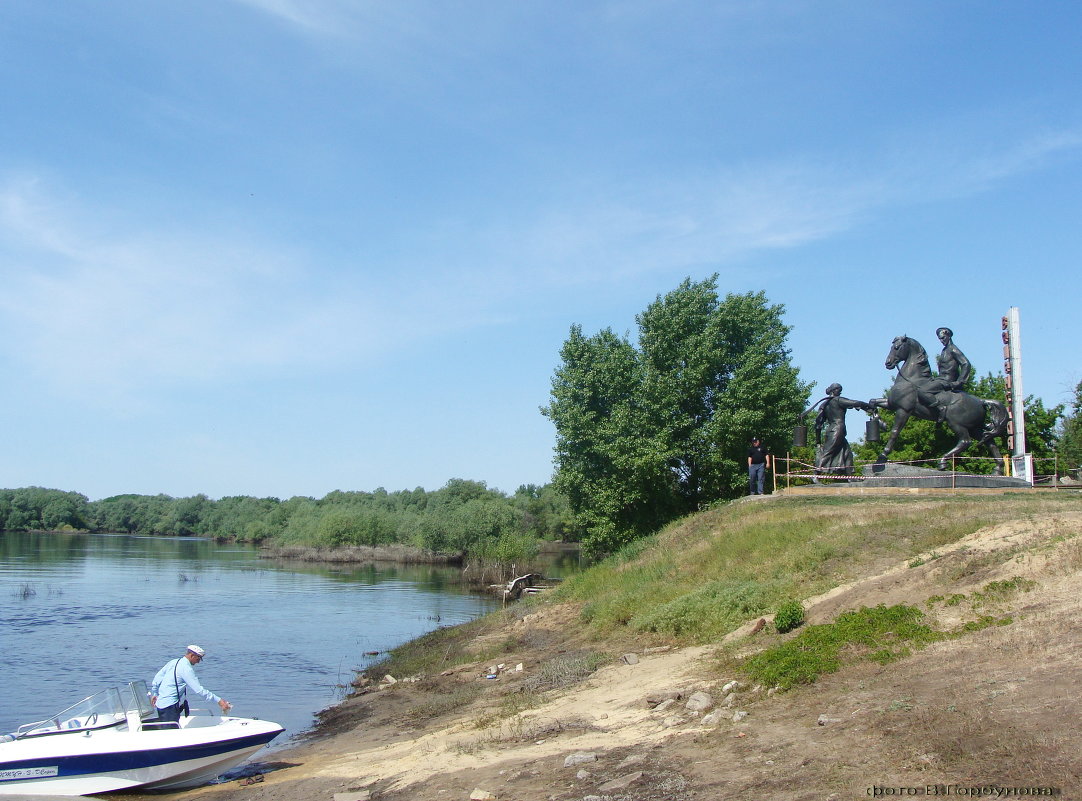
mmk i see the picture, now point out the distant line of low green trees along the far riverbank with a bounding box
[0,478,578,555]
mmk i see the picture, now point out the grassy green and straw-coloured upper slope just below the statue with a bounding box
[369,493,1082,678]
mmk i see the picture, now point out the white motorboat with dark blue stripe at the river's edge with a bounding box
[0,681,285,796]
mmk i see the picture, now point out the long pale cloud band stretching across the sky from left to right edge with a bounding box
[0,120,1082,406]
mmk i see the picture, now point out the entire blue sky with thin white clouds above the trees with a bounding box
[0,0,1082,500]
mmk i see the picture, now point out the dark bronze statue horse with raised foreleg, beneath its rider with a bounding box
[869,337,1007,475]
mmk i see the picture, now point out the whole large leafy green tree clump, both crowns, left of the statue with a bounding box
[542,275,808,552]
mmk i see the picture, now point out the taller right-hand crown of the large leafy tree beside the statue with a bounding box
[637,283,810,500]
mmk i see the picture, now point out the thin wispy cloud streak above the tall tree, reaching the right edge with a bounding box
[463,121,1082,284]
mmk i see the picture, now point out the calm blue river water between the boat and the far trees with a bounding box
[0,533,497,747]
